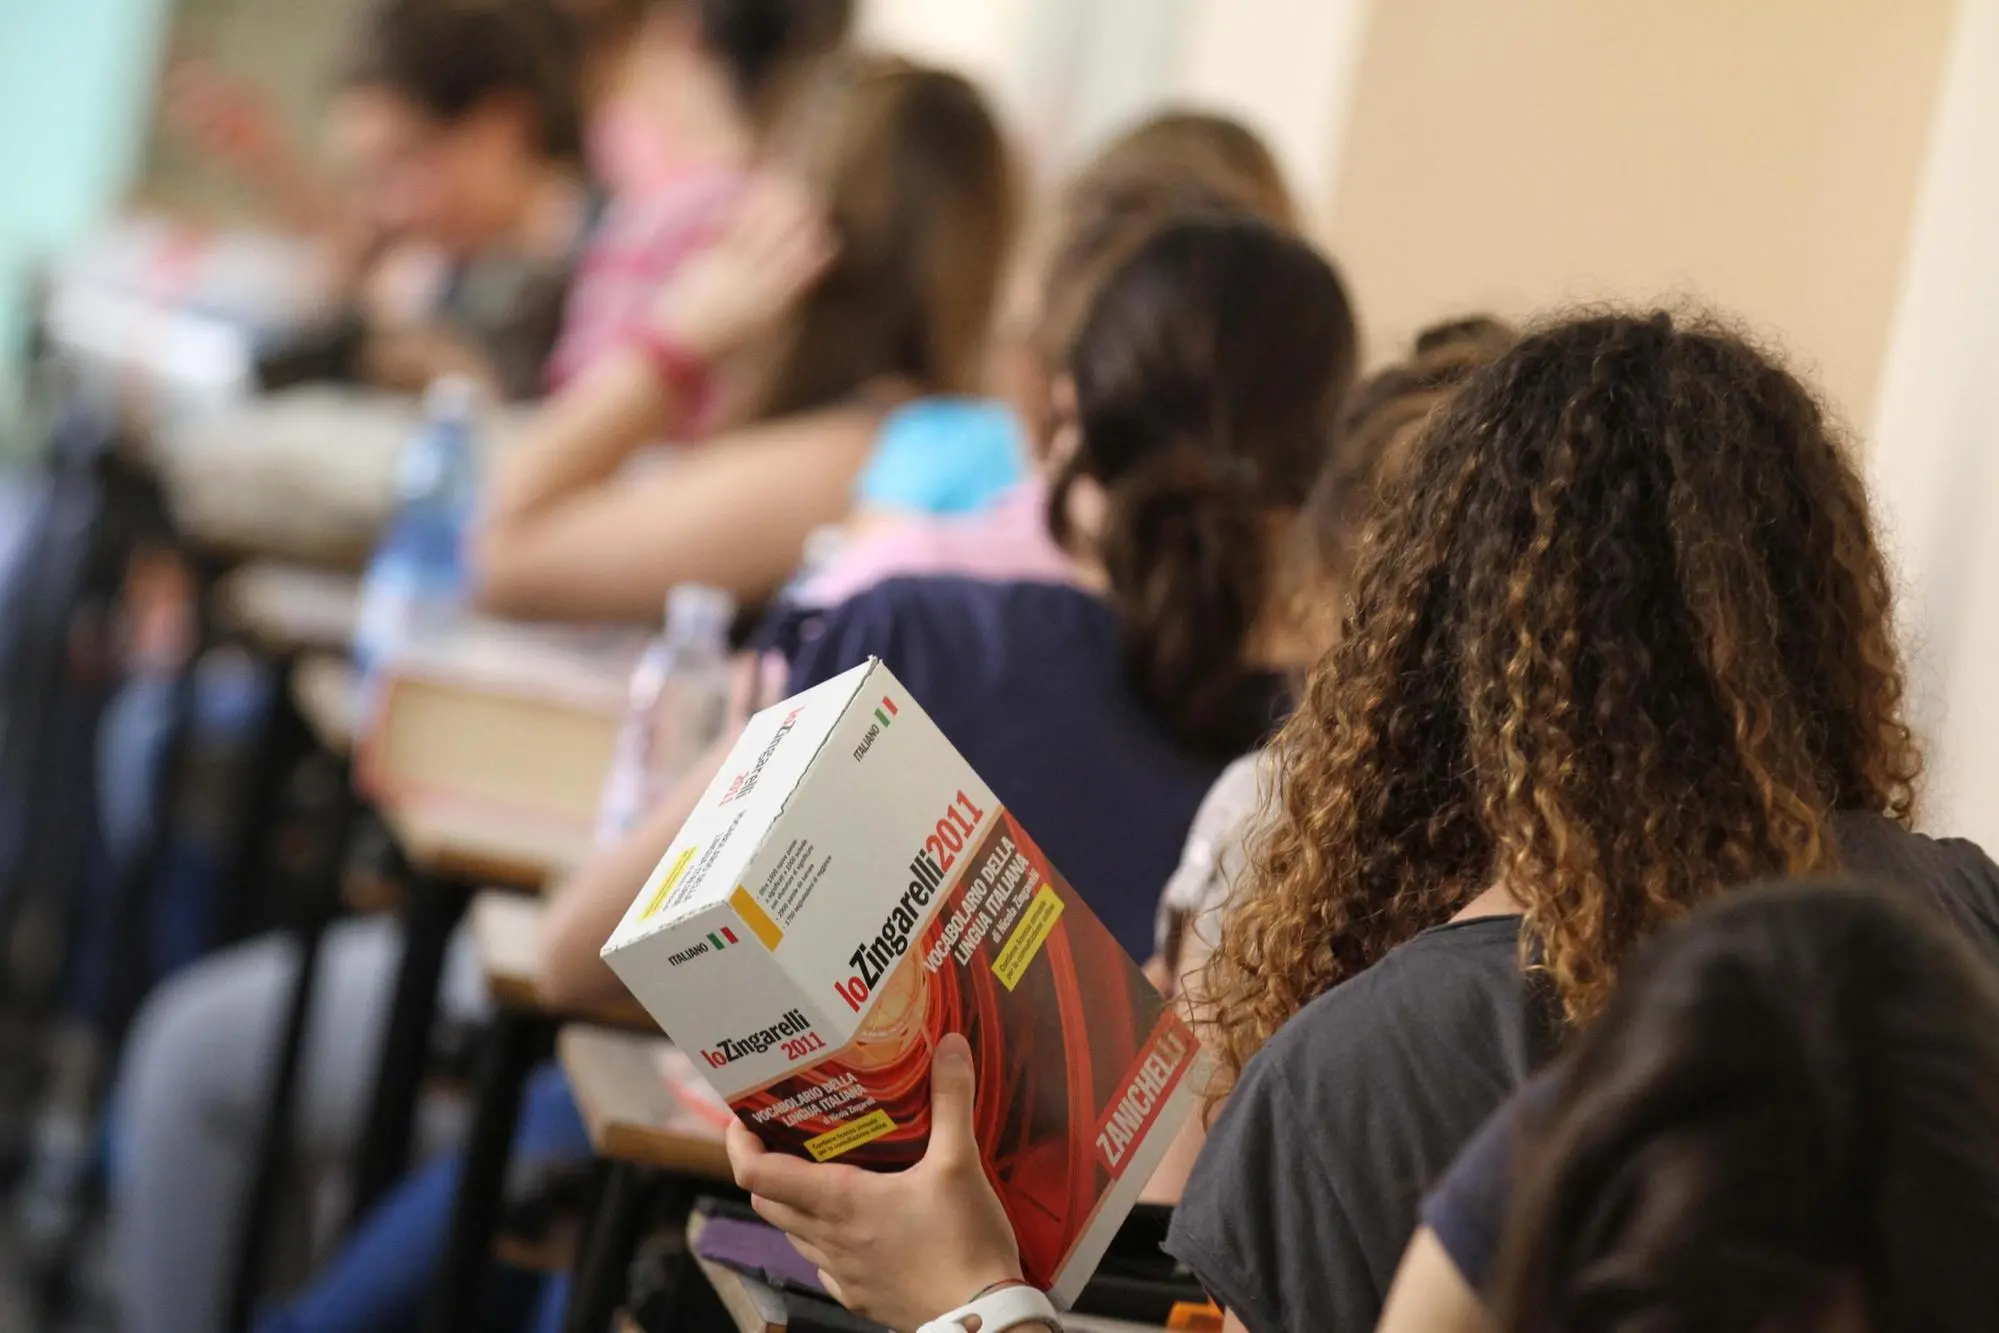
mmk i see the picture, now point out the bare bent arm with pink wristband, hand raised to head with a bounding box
[472,178,874,622]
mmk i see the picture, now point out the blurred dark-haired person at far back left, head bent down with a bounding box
[166,0,596,398]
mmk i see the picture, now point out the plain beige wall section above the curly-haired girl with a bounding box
[1331,0,1953,424]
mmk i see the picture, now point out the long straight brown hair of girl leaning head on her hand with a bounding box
[752,56,1015,416]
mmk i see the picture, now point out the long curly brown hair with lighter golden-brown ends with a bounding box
[1205,312,1919,1095]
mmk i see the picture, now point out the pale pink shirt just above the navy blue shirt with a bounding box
[796,478,1075,606]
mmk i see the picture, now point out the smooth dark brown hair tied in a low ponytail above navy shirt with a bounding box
[1049,218,1353,757]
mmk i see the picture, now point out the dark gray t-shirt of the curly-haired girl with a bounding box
[1165,815,1999,1333]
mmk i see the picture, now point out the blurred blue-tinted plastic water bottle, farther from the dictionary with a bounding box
[354,378,478,717]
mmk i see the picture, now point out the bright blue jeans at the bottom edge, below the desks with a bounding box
[258,1065,590,1333]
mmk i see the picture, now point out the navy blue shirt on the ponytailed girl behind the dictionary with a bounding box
[772,578,1283,961]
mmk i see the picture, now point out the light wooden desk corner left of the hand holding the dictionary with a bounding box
[556,1023,730,1181]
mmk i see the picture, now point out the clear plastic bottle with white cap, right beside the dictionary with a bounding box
[598,584,751,841]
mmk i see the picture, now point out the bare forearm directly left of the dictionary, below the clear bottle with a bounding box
[538,731,736,1009]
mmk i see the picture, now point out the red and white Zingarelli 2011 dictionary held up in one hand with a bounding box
[604,662,1203,1305]
